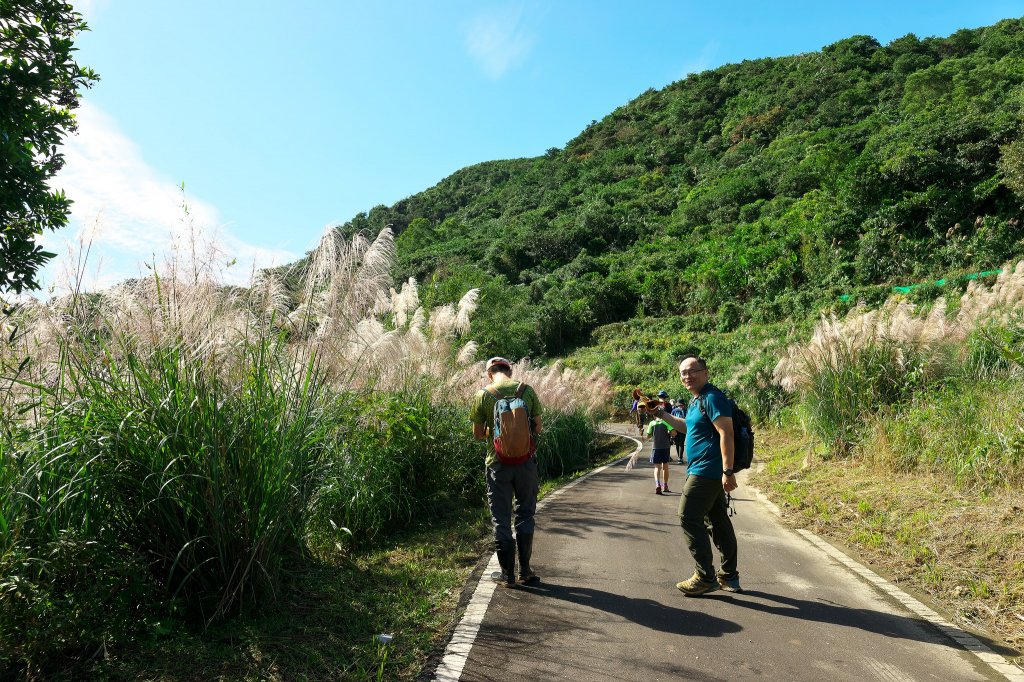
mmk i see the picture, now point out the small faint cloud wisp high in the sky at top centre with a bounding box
[464,5,537,80]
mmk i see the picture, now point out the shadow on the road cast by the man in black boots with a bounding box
[528,583,742,637]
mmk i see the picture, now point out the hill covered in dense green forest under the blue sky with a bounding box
[331,19,1024,357]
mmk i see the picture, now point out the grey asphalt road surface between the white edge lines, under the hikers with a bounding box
[461,421,1006,682]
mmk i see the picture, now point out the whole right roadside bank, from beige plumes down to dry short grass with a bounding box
[757,261,1024,655]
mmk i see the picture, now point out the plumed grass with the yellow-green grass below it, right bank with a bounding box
[774,262,1024,485]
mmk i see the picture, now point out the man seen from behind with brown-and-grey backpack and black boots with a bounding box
[469,357,542,587]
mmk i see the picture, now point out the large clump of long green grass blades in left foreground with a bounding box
[0,331,335,662]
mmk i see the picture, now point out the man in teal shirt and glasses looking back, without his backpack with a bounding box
[653,355,742,597]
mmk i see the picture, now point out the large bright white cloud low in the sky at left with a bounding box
[41,101,297,289]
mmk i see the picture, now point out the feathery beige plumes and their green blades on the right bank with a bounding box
[774,262,1024,453]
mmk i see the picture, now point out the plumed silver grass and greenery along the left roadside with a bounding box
[0,229,607,679]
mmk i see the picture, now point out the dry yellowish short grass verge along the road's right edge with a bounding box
[753,430,1024,650]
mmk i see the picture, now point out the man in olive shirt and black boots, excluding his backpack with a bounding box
[469,357,542,587]
